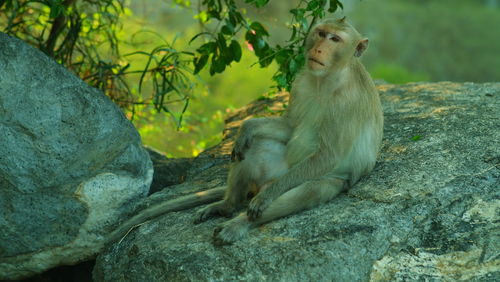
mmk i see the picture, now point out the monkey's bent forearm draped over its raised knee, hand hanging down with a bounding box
[231,117,292,161]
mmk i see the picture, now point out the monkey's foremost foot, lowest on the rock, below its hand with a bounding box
[213,214,251,246]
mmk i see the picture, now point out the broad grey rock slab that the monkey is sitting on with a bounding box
[94,82,500,281]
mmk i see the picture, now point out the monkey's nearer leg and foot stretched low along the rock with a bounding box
[214,179,344,245]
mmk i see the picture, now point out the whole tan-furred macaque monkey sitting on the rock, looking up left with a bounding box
[107,18,383,244]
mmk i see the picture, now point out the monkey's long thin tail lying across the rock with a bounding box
[105,186,226,245]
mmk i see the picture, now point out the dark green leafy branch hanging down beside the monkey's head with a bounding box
[191,0,342,90]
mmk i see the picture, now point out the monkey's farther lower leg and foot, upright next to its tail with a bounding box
[194,160,251,223]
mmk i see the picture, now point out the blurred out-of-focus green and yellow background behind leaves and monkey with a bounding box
[0,0,500,157]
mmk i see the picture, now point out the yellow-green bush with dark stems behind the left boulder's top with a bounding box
[0,0,137,110]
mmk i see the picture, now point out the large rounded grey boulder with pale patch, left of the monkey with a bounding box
[0,33,153,280]
